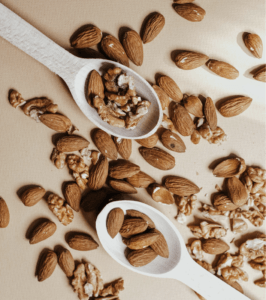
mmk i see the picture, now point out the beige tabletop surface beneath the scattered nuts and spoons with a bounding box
[0,0,266,300]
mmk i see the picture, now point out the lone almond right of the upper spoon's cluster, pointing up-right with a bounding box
[219,96,252,118]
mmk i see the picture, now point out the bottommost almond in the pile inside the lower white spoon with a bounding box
[127,247,158,267]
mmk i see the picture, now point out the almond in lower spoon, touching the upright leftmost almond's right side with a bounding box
[119,218,149,238]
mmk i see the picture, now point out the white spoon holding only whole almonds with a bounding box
[96,200,249,300]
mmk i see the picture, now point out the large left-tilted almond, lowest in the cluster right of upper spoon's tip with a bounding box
[169,103,195,136]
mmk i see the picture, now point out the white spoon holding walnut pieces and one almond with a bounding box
[0,4,163,139]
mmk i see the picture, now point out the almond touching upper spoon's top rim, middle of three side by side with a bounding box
[101,34,129,67]
